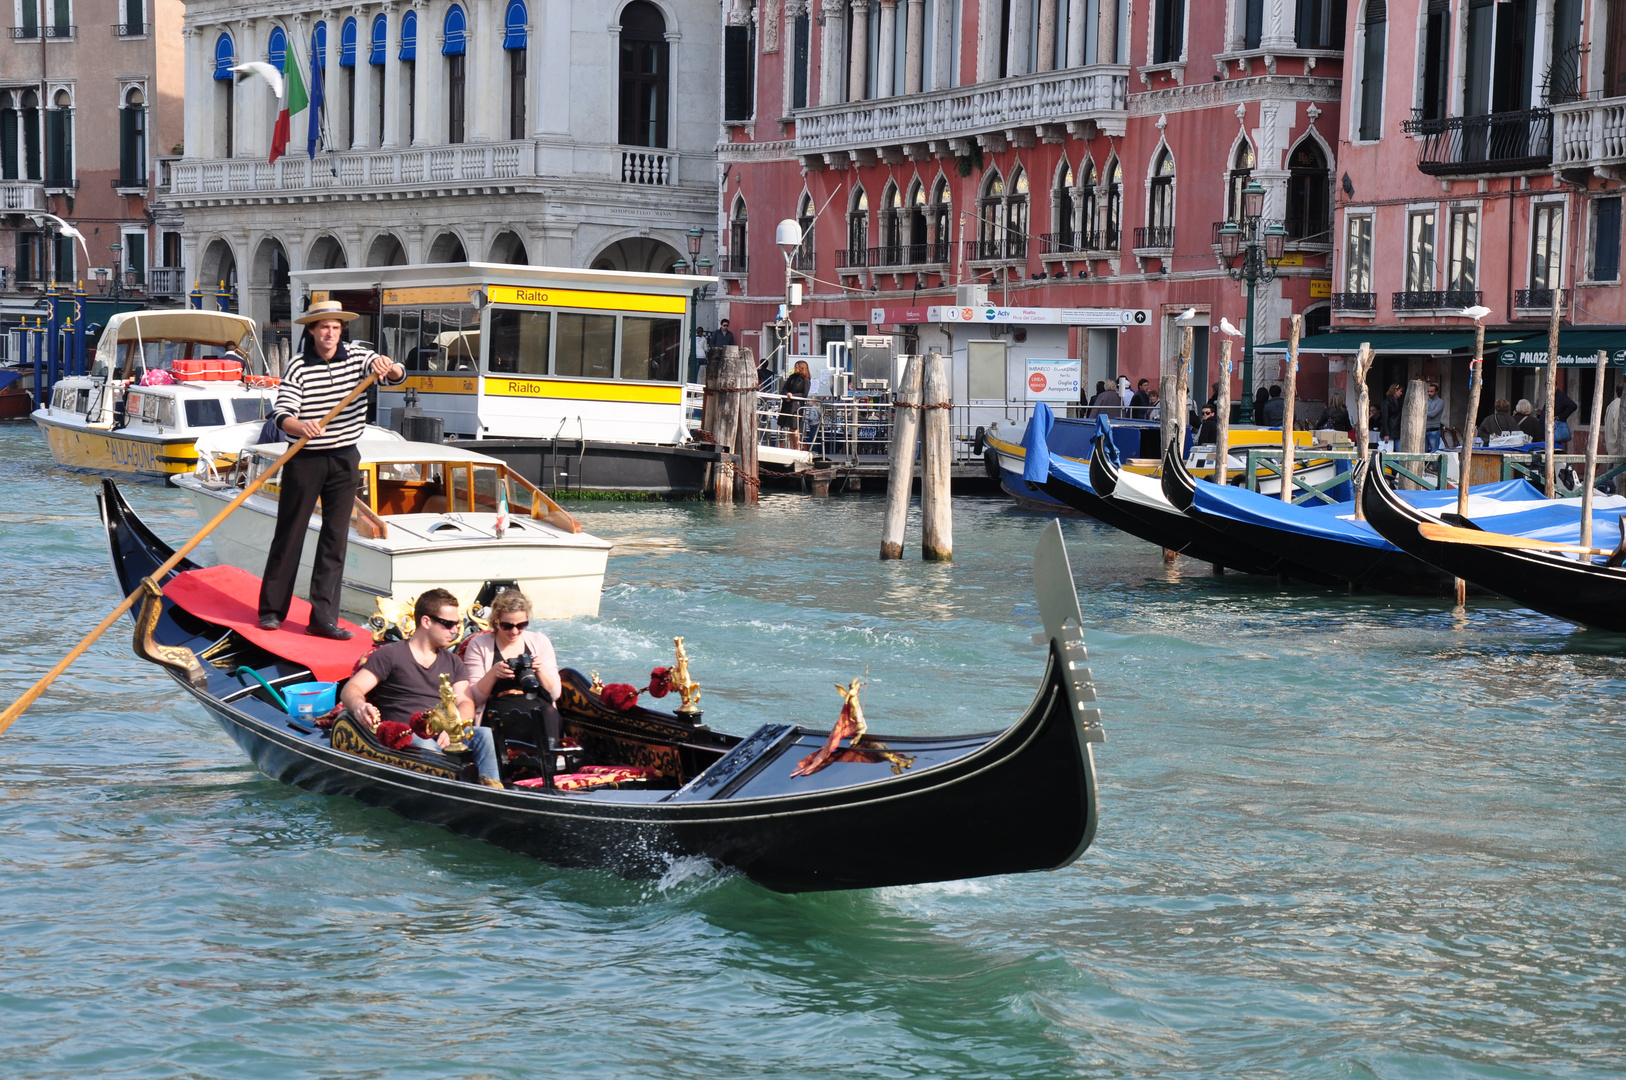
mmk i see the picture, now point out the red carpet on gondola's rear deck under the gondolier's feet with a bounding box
[164,566,372,683]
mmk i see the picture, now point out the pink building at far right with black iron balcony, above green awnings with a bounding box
[1332,0,1626,425]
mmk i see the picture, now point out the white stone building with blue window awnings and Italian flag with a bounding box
[158,0,720,335]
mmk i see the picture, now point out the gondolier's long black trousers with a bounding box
[260,446,361,626]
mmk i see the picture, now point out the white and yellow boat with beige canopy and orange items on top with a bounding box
[33,309,276,478]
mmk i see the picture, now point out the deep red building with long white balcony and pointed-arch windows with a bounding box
[719,0,1346,414]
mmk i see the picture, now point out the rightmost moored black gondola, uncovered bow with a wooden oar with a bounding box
[1361,457,1626,633]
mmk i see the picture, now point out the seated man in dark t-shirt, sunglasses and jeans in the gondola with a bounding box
[340,589,502,787]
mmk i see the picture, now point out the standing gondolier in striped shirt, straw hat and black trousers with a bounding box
[260,301,407,641]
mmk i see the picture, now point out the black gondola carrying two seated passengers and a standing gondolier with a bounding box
[99,480,1101,891]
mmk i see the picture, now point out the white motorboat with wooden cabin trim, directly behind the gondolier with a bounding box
[174,425,611,621]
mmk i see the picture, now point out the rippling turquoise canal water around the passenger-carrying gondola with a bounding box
[0,425,1626,1080]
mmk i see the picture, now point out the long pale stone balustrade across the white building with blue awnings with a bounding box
[158,142,693,205]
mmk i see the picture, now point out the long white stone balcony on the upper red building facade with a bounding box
[795,65,1128,168]
